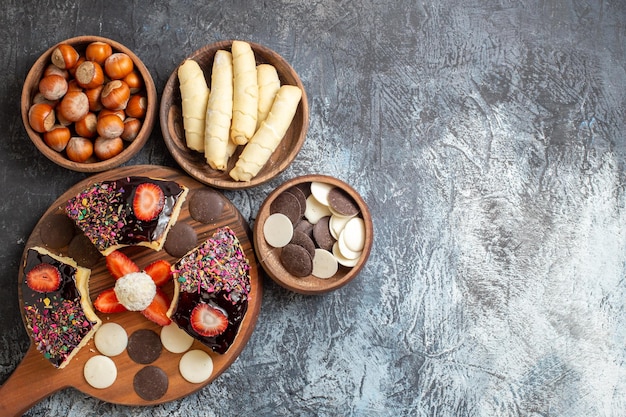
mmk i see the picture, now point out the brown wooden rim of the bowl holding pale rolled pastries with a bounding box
[159,40,309,190]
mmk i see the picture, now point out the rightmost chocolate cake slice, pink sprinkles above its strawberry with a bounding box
[168,227,250,354]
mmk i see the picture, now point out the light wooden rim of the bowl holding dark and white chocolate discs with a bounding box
[253,174,374,295]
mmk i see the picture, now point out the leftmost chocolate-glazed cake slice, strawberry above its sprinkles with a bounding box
[21,247,102,369]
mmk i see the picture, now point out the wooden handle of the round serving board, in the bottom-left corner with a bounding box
[0,344,69,417]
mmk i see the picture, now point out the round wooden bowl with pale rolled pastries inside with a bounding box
[159,40,309,189]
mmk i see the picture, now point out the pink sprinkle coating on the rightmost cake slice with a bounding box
[174,226,250,304]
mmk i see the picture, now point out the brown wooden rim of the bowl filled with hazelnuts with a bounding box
[21,35,158,173]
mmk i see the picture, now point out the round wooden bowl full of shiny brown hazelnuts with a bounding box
[21,36,158,172]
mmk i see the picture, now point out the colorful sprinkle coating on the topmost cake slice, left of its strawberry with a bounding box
[65,179,128,250]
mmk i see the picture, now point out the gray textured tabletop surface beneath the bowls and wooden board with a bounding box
[0,0,626,417]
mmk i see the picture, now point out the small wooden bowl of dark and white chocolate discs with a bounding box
[253,174,374,294]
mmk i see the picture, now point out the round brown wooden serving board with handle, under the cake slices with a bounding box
[0,165,262,417]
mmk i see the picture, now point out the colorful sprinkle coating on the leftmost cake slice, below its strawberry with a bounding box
[24,297,93,367]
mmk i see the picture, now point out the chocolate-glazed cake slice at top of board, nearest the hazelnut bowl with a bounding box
[65,177,189,256]
